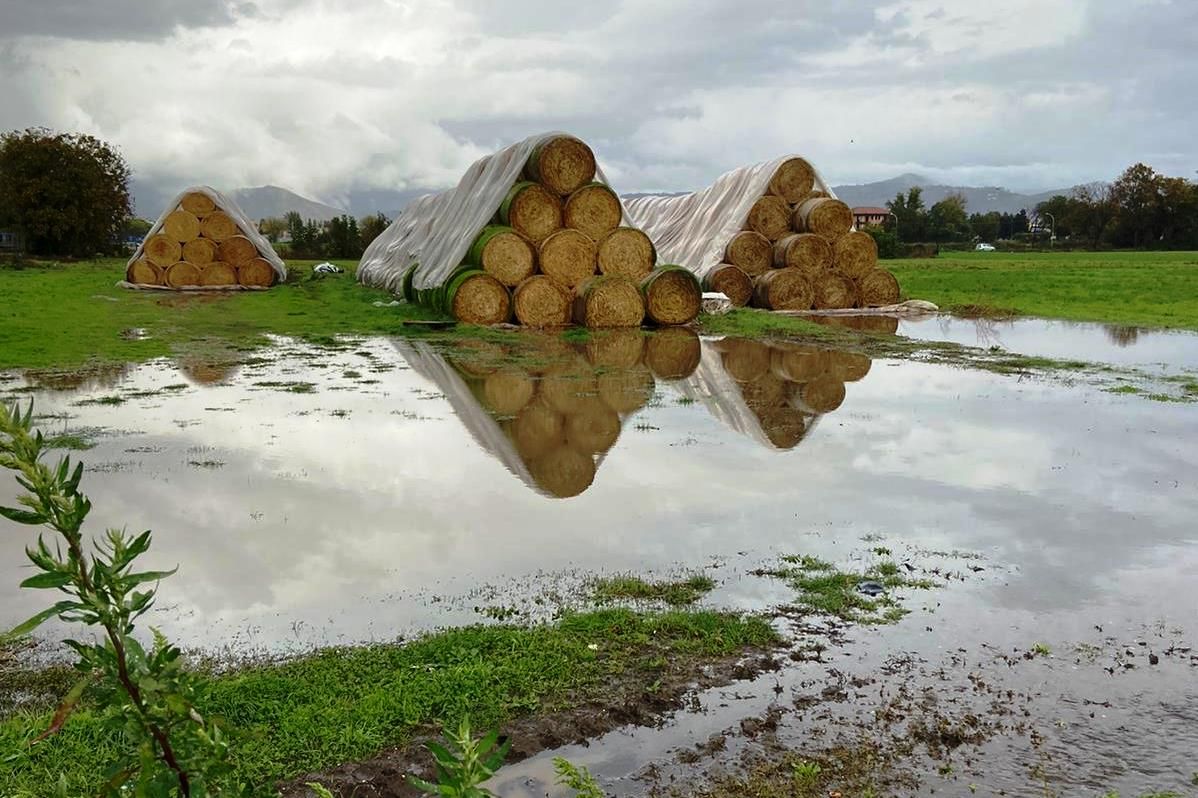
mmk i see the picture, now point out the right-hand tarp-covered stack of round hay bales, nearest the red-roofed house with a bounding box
[625,156,900,310]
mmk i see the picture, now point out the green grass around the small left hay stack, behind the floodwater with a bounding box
[0,259,430,369]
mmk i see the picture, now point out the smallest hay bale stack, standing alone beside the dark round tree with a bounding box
[126,186,286,289]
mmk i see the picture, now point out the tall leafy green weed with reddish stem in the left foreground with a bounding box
[0,403,240,798]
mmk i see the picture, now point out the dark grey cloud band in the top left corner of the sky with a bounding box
[0,0,254,41]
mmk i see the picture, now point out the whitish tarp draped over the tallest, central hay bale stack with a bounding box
[358,132,627,294]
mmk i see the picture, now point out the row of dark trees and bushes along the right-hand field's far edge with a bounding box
[872,163,1198,249]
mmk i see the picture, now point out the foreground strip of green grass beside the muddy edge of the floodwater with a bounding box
[0,609,776,797]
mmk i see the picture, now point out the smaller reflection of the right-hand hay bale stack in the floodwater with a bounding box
[684,338,871,449]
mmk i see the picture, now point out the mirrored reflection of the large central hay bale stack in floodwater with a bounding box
[395,327,701,498]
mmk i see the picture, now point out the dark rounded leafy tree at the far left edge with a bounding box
[0,128,132,258]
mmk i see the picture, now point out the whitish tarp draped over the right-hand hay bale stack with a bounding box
[624,156,835,278]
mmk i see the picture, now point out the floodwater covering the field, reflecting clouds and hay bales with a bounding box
[0,320,1198,796]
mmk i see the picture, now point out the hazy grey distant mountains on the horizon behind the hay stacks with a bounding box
[133,174,1071,222]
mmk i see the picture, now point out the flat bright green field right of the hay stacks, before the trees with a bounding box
[883,252,1198,330]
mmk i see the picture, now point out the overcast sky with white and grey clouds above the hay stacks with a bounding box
[0,0,1198,209]
